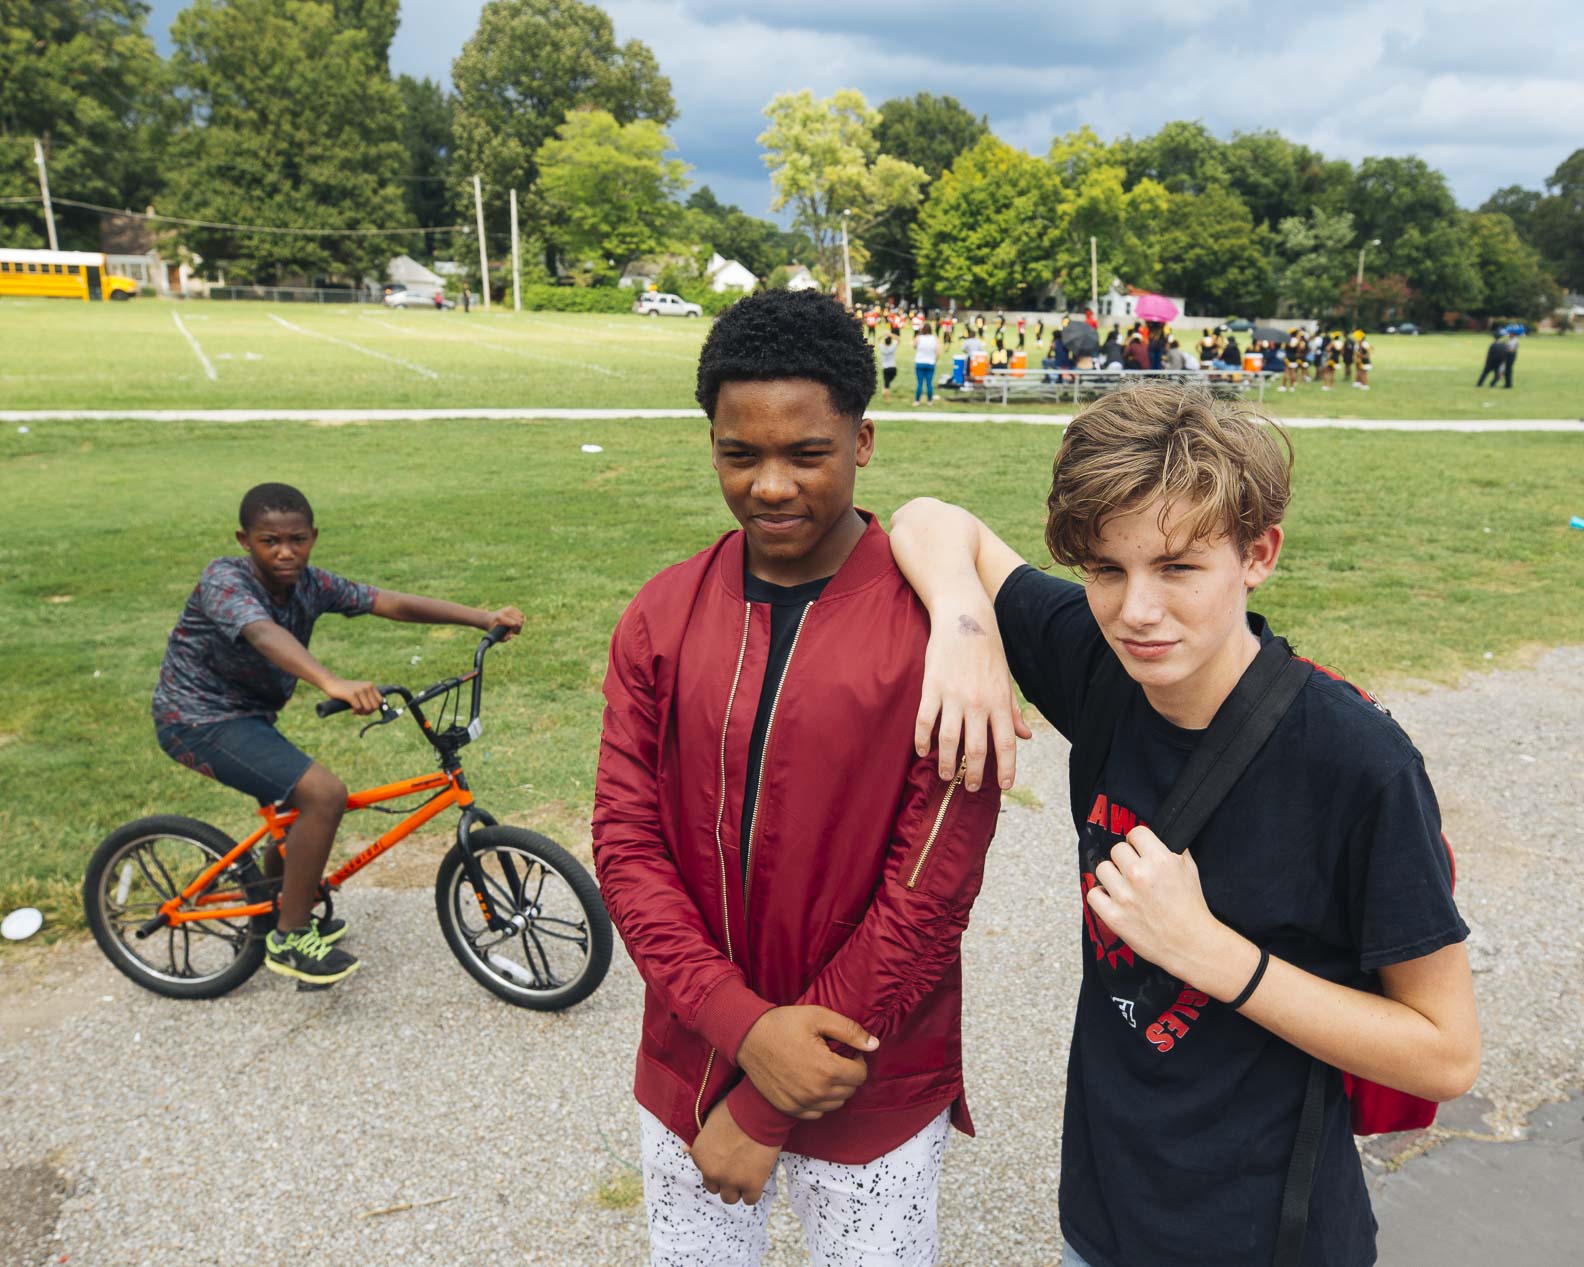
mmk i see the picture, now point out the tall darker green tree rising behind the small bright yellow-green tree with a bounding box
[451,0,676,263]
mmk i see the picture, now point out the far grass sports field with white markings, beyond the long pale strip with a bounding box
[0,299,1584,418]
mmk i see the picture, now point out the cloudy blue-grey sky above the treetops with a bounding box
[150,0,1584,215]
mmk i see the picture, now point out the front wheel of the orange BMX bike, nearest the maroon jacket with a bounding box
[434,827,610,1012]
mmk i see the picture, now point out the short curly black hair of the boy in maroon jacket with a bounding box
[694,287,874,424]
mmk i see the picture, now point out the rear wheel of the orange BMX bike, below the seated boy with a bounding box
[82,816,271,999]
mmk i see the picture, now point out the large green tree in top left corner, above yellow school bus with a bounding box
[0,0,168,250]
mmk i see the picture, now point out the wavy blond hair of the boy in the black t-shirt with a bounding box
[1045,383,1293,567]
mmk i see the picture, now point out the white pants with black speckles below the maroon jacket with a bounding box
[638,1107,950,1267]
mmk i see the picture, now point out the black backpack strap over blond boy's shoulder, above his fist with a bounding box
[1150,638,1310,854]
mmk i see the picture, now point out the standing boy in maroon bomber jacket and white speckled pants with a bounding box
[594,290,1000,1264]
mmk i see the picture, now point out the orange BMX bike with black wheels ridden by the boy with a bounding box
[82,626,610,1010]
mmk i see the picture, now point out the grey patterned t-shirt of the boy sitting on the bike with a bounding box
[154,556,379,725]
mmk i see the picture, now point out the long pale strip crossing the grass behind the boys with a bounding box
[0,409,1584,436]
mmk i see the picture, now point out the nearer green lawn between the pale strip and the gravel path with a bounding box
[0,411,1584,928]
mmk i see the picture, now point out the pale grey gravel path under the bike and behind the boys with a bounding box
[0,648,1584,1267]
